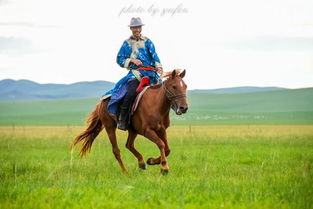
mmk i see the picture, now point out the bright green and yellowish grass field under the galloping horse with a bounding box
[0,125,313,209]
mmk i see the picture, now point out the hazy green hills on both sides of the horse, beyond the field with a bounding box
[0,88,313,125]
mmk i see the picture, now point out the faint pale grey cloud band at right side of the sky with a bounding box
[210,36,313,51]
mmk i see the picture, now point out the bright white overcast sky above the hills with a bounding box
[0,0,313,89]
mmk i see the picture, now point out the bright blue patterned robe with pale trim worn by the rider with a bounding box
[103,36,162,115]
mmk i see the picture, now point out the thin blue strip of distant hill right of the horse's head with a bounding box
[189,86,286,94]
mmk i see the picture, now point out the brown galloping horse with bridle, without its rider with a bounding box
[71,70,188,174]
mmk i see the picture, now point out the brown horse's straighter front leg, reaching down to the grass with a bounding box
[144,128,169,174]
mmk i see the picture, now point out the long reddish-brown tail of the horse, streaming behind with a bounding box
[71,100,105,157]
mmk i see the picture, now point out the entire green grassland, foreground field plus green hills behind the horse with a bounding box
[0,88,313,209]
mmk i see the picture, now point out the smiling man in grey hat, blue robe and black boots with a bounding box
[104,17,163,130]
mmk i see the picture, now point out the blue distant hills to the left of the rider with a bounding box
[0,79,114,101]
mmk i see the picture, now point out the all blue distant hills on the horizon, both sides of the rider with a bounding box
[0,79,290,101]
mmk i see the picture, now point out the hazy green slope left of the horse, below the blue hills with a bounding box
[0,98,99,126]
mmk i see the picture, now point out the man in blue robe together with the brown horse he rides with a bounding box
[71,18,188,174]
